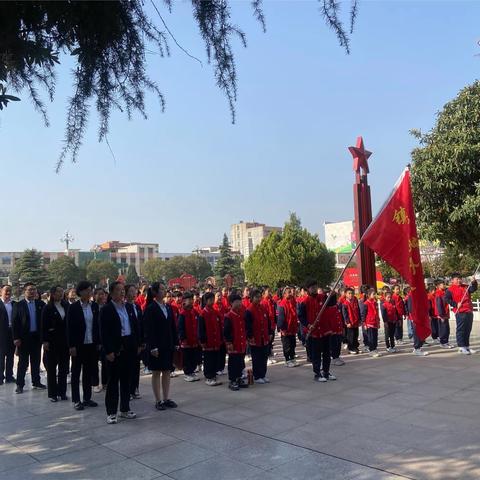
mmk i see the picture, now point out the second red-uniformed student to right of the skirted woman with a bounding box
[198,292,223,387]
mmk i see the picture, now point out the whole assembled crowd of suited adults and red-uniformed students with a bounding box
[0,274,477,424]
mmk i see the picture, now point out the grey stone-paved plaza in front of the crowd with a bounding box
[0,342,480,480]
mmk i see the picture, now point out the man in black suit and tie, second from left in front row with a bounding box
[12,282,47,393]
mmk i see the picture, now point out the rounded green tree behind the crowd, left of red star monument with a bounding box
[245,213,335,287]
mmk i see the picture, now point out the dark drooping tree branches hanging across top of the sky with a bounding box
[0,0,357,170]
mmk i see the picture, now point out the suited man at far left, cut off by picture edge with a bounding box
[0,285,16,385]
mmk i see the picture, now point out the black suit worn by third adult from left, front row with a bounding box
[41,301,70,399]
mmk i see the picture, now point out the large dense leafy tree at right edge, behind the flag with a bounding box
[412,81,480,253]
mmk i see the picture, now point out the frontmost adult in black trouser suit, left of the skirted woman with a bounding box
[100,282,140,424]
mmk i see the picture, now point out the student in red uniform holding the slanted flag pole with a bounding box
[298,281,339,382]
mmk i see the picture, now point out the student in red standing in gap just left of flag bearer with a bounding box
[277,287,298,368]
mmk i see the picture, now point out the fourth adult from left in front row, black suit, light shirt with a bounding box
[67,281,100,410]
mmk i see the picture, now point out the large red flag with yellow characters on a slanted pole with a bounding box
[362,169,431,340]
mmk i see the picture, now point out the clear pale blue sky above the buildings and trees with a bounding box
[0,0,480,252]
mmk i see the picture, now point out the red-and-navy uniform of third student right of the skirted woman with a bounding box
[223,309,247,384]
